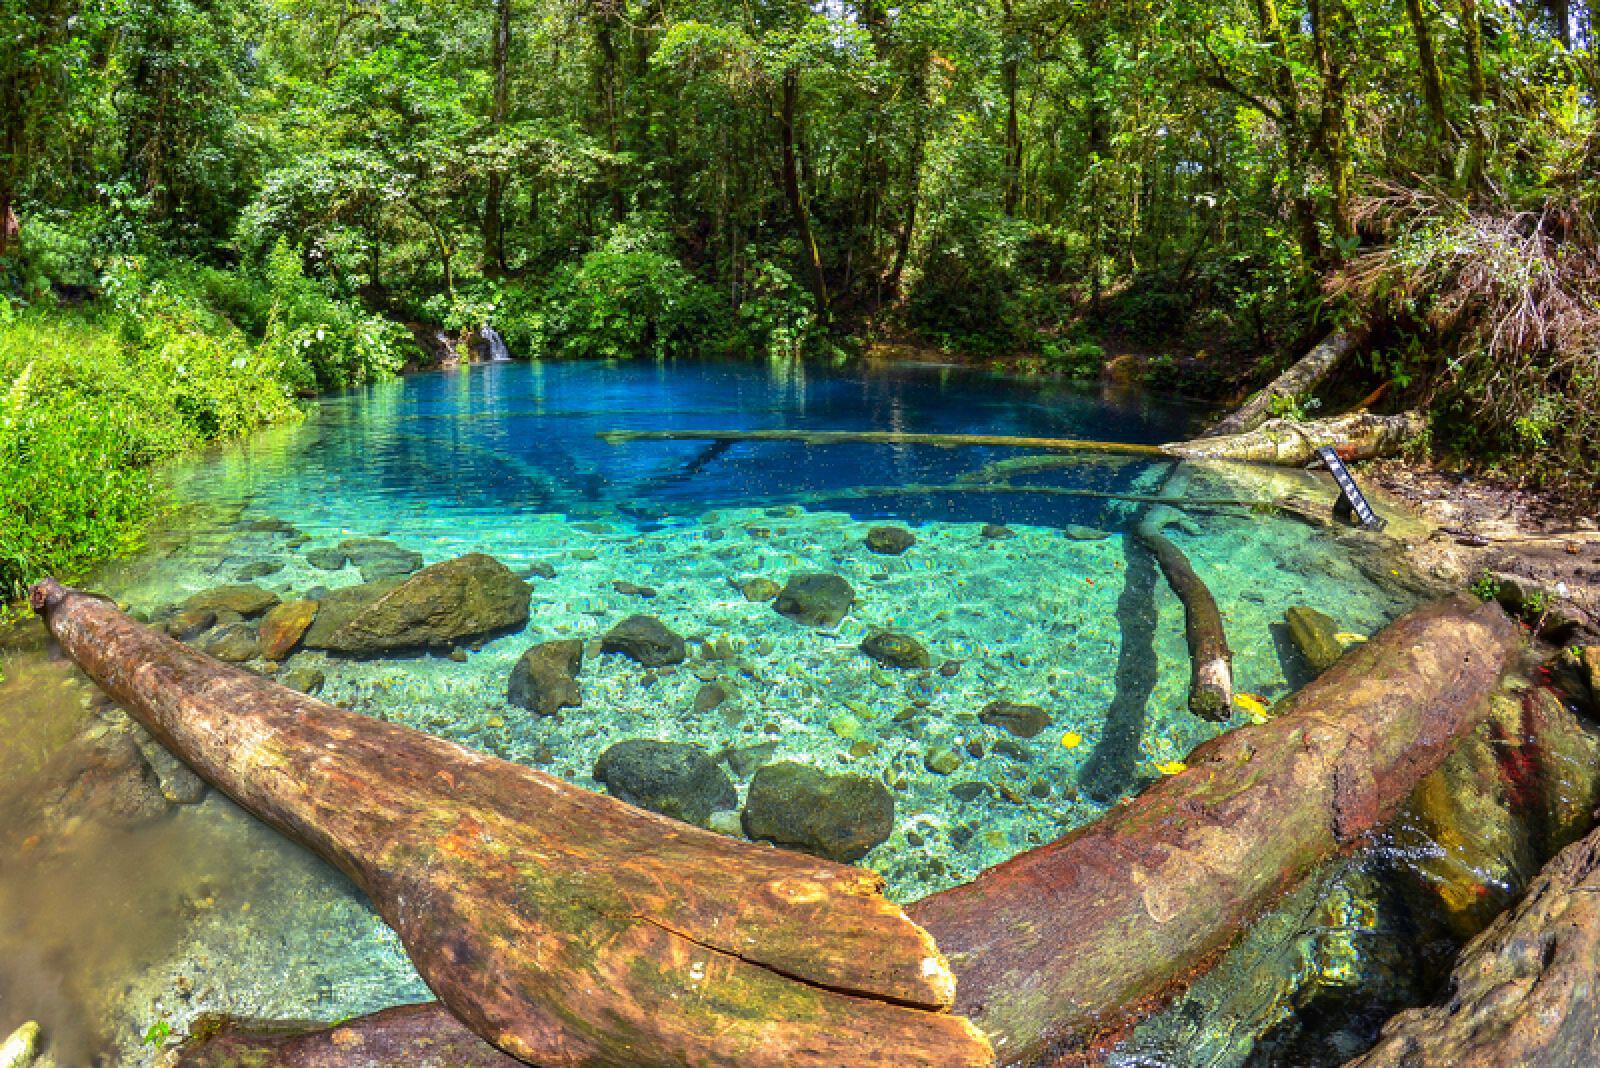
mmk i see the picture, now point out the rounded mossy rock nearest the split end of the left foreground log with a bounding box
[744,761,894,862]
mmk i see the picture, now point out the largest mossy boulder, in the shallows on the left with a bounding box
[304,553,533,656]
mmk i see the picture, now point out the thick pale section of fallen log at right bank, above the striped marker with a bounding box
[1162,411,1427,467]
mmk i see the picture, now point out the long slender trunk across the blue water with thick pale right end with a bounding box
[598,412,1426,467]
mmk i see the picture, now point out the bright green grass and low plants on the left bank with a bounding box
[0,252,403,604]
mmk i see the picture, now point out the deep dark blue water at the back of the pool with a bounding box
[249,361,1202,524]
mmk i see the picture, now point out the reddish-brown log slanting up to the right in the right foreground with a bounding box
[909,596,1518,1063]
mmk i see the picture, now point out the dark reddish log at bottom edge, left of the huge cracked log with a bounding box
[171,1001,523,1068]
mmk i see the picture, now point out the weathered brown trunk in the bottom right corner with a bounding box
[1346,831,1600,1068]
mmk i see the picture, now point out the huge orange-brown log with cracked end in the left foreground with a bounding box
[32,580,992,1068]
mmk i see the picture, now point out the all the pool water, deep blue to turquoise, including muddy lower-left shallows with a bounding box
[0,356,1427,1063]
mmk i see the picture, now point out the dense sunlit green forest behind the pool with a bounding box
[0,0,1600,597]
